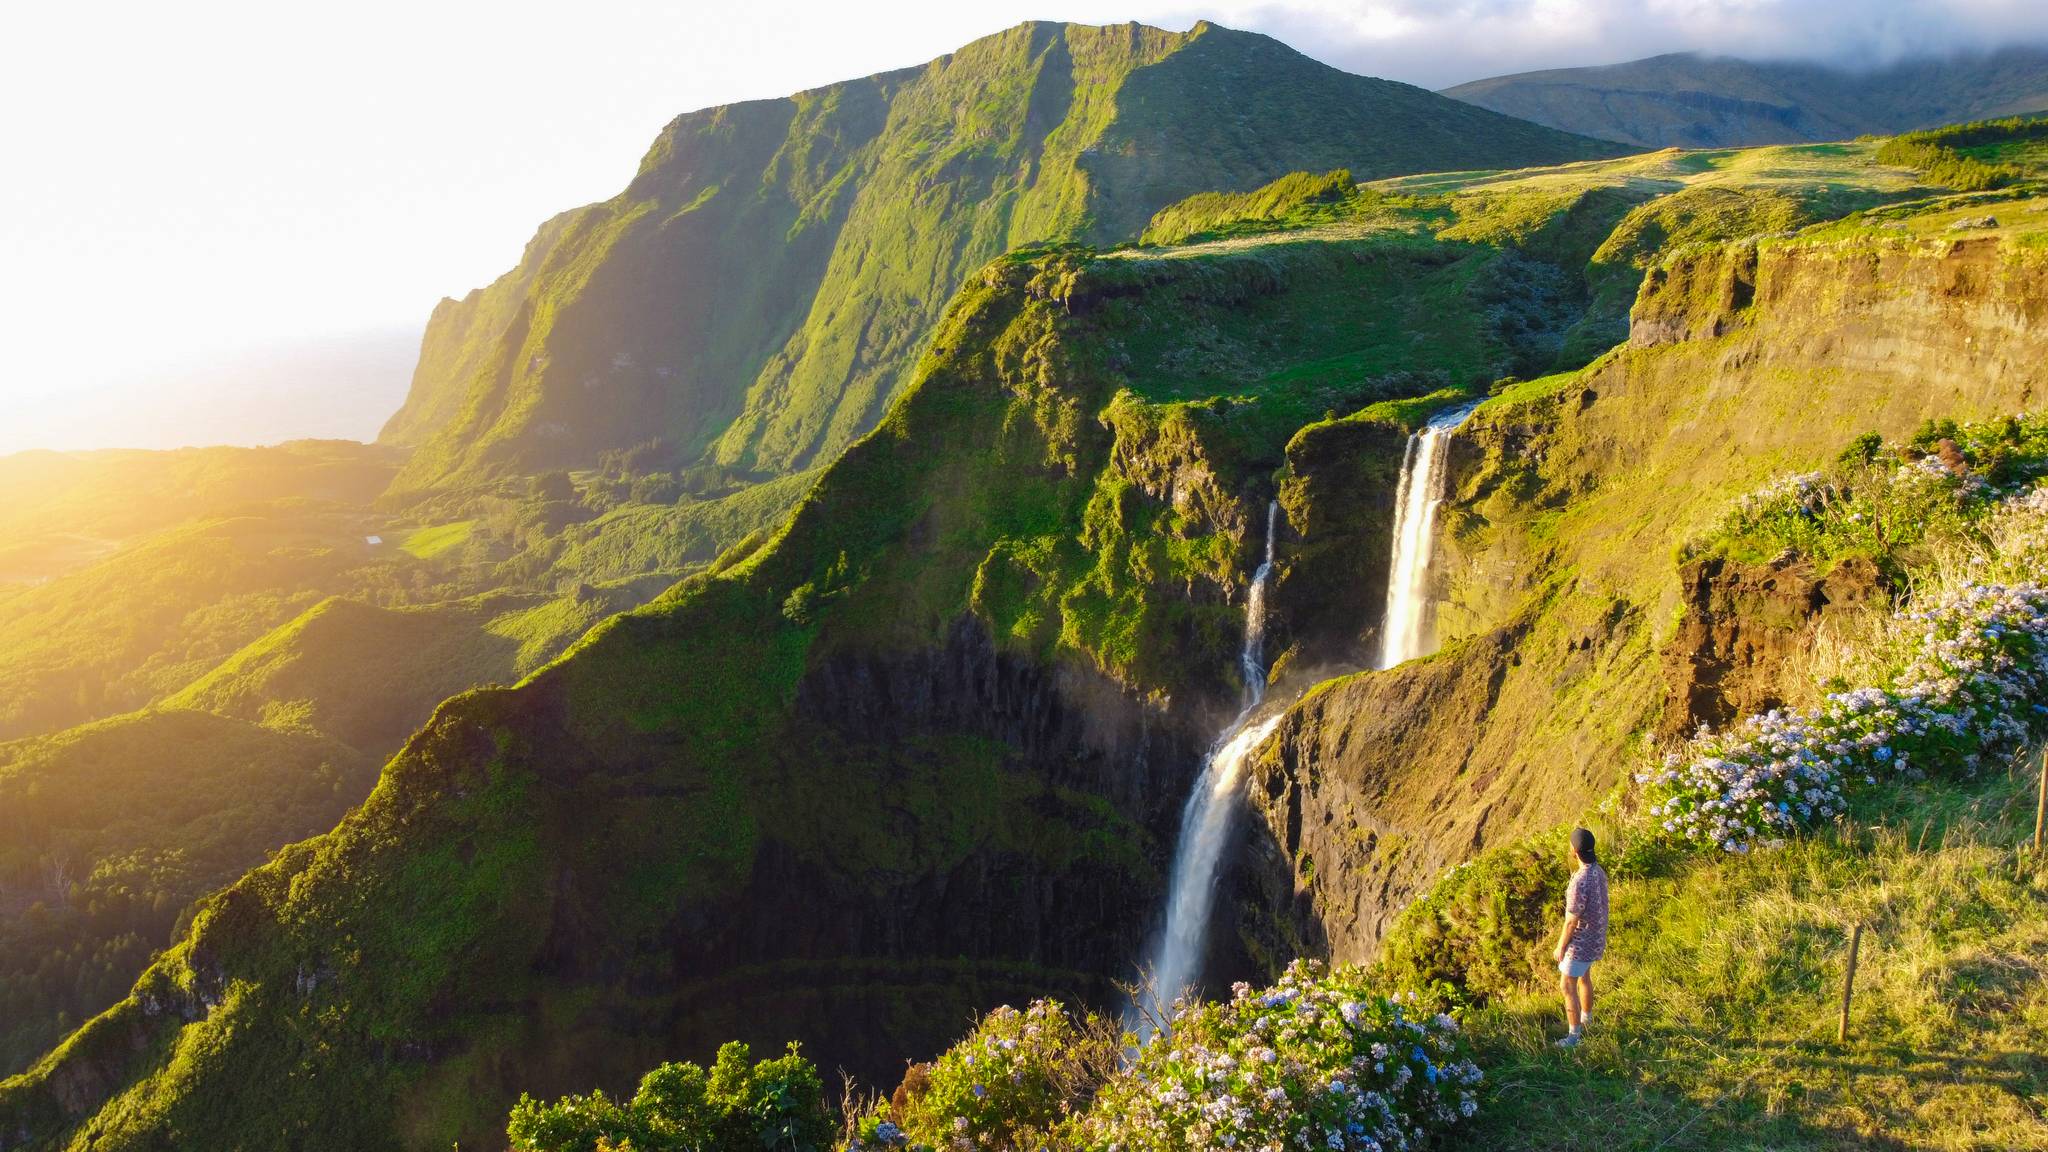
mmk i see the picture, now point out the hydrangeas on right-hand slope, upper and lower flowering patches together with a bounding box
[1636,422,2048,853]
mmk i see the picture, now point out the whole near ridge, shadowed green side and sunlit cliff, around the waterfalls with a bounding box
[16,123,2048,1148]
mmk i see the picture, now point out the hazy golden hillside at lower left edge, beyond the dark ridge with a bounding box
[0,709,377,1068]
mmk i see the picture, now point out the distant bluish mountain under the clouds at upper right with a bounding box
[1444,47,2048,148]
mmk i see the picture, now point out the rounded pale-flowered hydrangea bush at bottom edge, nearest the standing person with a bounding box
[1077,961,1481,1152]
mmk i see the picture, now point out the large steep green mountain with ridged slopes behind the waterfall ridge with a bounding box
[383,23,1618,492]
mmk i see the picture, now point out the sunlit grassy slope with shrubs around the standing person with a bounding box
[1380,420,2048,1148]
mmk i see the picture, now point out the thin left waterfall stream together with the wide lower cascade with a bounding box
[1128,500,1280,1024]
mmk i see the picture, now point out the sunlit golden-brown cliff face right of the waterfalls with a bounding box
[1239,219,2048,959]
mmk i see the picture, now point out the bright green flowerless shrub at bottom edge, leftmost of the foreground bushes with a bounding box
[506,1043,834,1152]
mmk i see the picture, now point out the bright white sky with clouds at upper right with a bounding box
[0,0,2048,453]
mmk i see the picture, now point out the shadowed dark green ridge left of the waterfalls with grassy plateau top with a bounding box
[0,127,1990,1148]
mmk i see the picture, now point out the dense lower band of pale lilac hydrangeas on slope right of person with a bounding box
[1636,479,2048,853]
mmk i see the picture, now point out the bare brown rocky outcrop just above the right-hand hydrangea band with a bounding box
[1657,556,1886,736]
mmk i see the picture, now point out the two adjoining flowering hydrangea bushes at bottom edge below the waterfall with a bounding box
[846,961,1481,1152]
